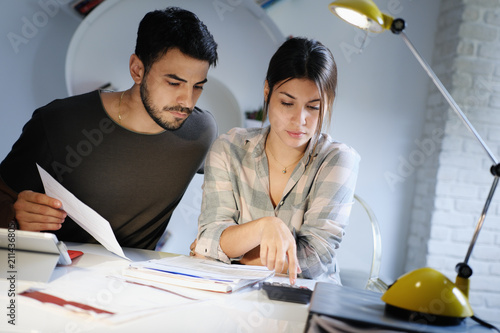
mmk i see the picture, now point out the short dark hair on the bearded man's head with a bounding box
[135,7,217,73]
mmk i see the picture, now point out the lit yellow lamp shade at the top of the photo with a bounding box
[328,0,394,32]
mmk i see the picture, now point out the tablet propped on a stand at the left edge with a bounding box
[0,228,71,265]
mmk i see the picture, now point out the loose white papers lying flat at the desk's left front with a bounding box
[19,261,202,322]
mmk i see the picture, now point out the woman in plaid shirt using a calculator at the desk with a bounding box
[191,38,359,284]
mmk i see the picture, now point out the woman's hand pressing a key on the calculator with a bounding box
[260,218,301,284]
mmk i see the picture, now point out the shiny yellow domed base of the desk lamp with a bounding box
[382,267,473,319]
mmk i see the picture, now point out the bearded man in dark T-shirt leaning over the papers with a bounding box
[0,7,217,249]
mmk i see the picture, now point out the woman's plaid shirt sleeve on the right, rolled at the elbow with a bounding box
[297,147,360,279]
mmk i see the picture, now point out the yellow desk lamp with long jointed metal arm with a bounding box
[329,0,500,325]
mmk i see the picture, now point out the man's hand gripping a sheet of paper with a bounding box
[14,191,67,231]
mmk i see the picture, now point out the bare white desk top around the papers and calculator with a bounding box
[0,243,314,333]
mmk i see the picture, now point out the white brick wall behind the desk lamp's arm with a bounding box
[406,0,500,321]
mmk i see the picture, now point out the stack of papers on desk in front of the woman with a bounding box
[123,256,274,293]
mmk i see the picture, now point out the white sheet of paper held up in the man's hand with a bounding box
[36,164,130,260]
